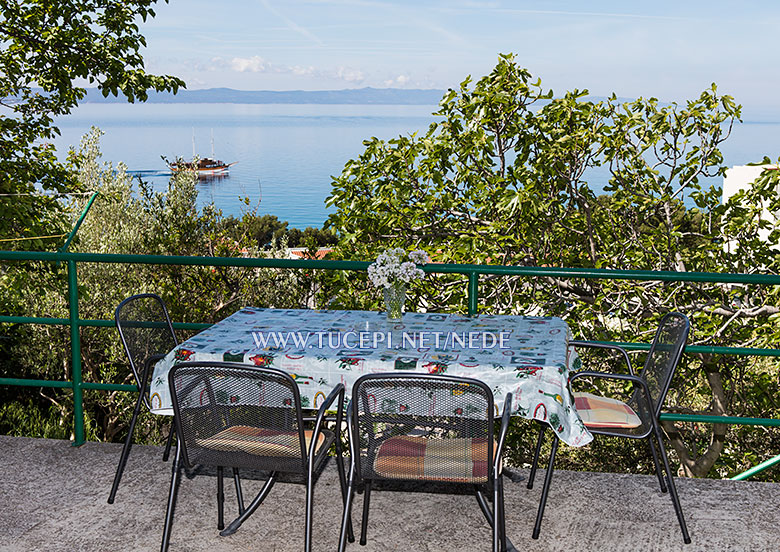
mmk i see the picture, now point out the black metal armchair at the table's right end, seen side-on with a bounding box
[528,312,691,544]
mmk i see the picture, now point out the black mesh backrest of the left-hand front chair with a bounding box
[168,362,307,472]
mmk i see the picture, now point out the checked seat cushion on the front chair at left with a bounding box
[195,425,325,457]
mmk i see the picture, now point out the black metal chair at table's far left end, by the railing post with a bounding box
[108,293,179,504]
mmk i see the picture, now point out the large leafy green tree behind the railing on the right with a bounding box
[328,55,780,475]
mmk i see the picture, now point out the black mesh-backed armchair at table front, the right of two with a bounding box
[339,374,512,552]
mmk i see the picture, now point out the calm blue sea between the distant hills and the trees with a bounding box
[50,103,780,229]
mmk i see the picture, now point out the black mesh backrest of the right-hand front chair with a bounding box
[351,373,494,483]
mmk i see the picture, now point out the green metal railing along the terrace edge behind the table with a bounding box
[0,249,780,479]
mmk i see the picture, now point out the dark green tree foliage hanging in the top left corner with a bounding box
[0,0,184,247]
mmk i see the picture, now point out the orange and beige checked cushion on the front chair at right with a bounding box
[374,435,497,483]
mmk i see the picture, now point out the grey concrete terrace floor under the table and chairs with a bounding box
[0,436,780,552]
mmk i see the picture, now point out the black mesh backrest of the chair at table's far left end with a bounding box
[114,293,179,406]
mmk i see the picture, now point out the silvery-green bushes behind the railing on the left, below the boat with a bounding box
[0,129,314,442]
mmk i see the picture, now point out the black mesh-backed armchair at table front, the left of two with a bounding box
[160,362,346,552]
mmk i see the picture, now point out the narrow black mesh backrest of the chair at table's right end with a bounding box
[637,312,691,418]
